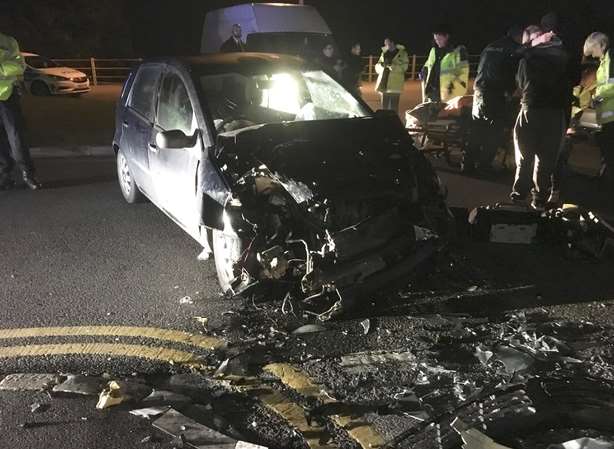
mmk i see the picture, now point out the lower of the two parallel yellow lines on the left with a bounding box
[0,343,202,367]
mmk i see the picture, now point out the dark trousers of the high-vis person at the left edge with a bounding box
[0,91,34,181]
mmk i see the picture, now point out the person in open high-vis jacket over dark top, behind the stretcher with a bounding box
[420,26,469,102]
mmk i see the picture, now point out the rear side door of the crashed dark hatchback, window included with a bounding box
[119,64,163,198]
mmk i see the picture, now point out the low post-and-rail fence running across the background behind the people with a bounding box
[54,55,480,86]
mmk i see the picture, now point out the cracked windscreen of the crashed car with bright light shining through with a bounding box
[200,70,371,132]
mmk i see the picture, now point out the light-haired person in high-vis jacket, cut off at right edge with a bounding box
[584,32,614,190]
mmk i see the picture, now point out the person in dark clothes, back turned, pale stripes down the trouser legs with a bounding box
[510,25,569,210]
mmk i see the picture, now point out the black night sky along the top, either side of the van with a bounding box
[0,0,614,57]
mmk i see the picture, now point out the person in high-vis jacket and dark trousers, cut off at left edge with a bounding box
[0,33,41,190]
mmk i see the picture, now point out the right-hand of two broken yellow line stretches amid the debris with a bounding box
[264,363,384,449]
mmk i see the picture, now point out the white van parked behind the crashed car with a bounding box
[201,3,332,55]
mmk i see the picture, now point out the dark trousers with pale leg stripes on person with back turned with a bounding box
[512,108,565,201]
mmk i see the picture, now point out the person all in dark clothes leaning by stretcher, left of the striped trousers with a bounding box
[461,27,523,172]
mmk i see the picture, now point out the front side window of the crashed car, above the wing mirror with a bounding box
[157,73,194,136]
